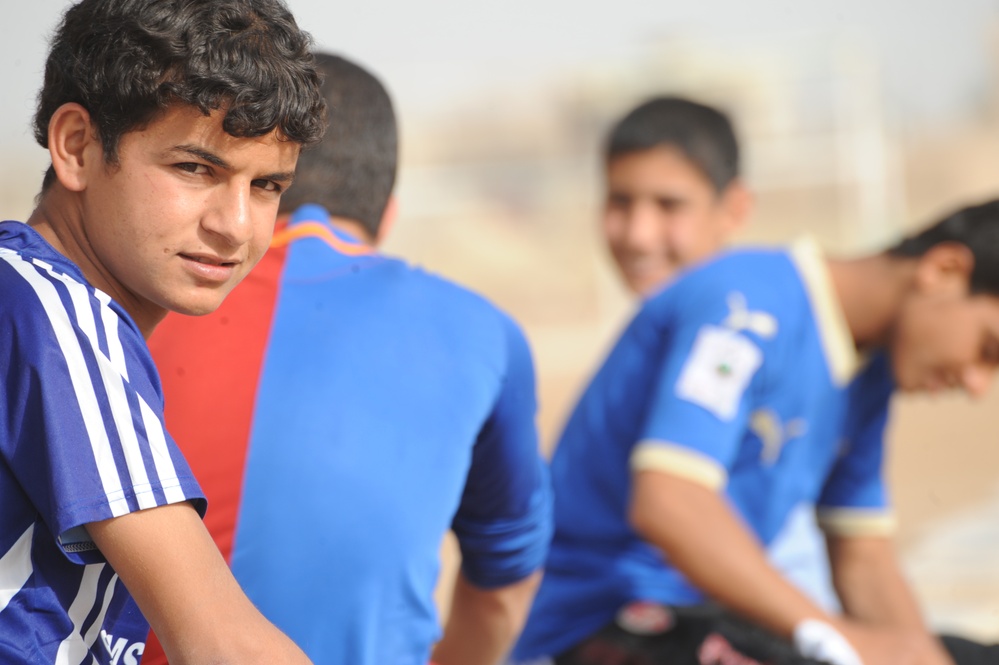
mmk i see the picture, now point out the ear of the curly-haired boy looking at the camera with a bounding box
[49,102,103,192]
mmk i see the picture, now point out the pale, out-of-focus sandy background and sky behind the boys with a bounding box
[7,0,999,640]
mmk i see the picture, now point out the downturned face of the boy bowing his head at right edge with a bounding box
[890,250,999,397]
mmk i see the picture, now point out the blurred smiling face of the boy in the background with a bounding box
[603,146,751,295]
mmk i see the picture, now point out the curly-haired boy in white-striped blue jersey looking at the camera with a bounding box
[0,0,325,665]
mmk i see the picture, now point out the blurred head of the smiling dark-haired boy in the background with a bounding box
[602,97,753,296]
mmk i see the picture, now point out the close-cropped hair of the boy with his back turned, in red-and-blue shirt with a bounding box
[281,53,398,237]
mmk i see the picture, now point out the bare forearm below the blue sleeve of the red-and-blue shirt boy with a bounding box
[433,571,541,665]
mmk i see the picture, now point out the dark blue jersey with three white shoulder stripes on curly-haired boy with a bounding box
[0,221,204,665]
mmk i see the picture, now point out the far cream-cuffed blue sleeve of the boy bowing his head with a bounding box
[816,357,895,536]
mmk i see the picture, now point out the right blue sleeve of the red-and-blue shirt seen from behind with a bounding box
[452,317,552,588]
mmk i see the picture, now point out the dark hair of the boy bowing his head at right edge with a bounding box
[887,200,999,295]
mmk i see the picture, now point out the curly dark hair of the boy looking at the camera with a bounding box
[34,0,326,191]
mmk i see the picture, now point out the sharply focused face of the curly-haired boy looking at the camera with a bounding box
[81,105,299,327]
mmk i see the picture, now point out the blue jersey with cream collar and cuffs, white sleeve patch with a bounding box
[515,242,893,659]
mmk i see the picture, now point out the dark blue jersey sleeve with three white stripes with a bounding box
[0,258,205,563]
